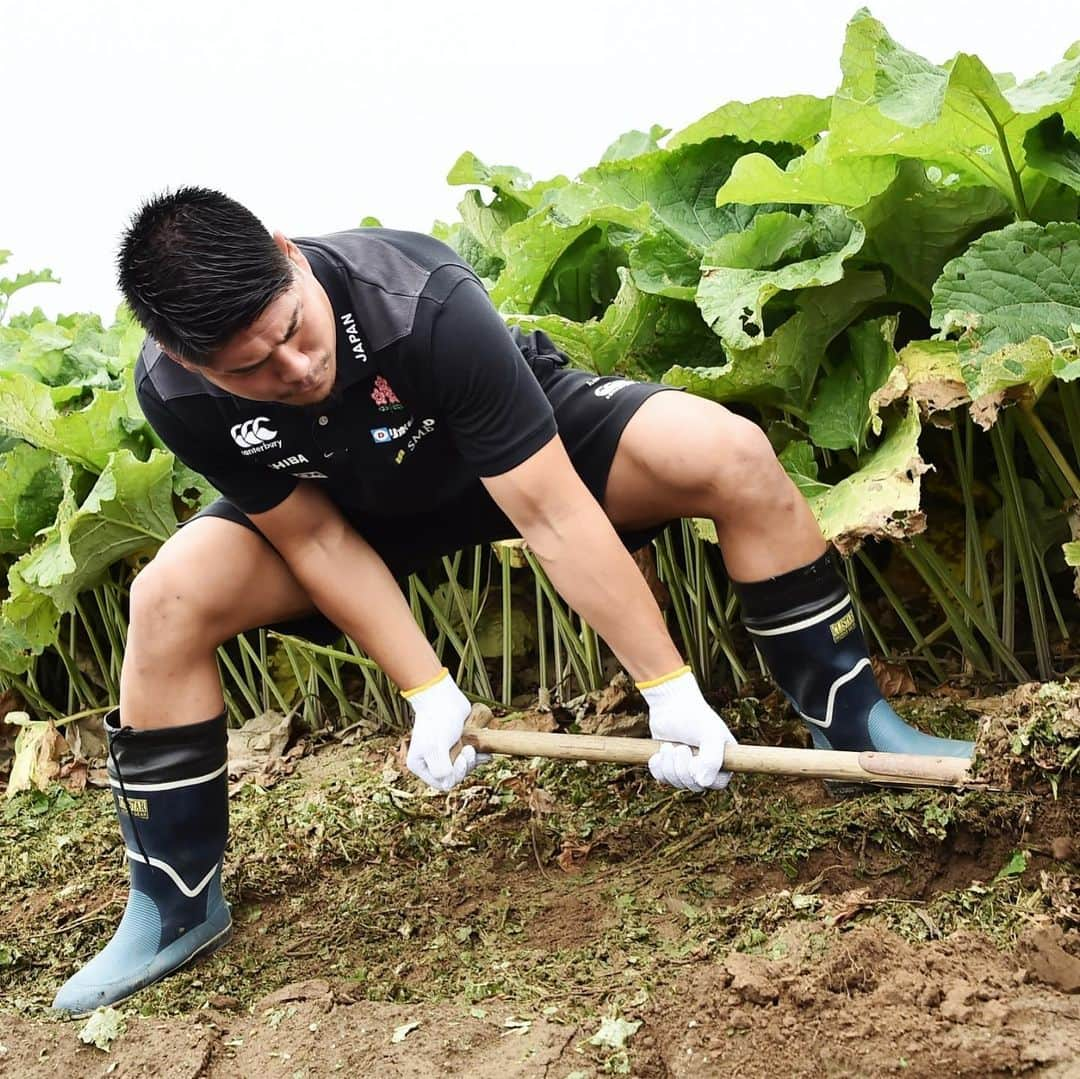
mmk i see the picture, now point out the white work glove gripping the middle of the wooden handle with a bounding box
[637,666,737,791]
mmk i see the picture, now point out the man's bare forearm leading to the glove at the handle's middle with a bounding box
[522,497,683,682]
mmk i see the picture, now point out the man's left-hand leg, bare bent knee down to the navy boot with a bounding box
[54,517,324,1014]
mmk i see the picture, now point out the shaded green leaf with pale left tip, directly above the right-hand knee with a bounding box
[661,272,885,415]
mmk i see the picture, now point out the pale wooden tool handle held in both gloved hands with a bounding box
[461,727,982,786]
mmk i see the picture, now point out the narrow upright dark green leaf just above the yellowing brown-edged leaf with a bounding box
[809,315,897,454]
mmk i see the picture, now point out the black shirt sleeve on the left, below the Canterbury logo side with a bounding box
[137,385,298,513]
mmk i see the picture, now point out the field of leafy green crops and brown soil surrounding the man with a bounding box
[0,12,1080,1079]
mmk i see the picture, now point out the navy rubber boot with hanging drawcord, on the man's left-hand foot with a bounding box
[53,711,232,1015]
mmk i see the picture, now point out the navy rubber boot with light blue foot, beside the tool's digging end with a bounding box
[732,552,974,757]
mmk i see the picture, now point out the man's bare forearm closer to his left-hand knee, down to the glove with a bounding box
[284,526,441,689]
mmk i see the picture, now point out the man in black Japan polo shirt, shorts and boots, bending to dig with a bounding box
[55,188,971,1012]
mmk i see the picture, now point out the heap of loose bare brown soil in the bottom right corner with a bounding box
[635,925,1080,1079]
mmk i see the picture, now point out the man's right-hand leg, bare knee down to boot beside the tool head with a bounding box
[604,393,973,756]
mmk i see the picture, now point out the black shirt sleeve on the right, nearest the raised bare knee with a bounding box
[419,279,557,476]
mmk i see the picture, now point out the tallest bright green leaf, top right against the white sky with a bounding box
[828,9,1080,216]
